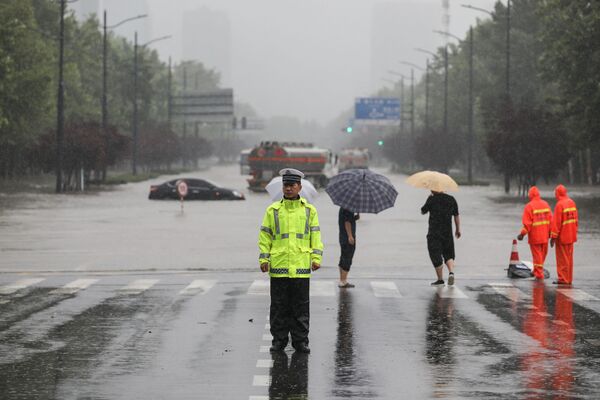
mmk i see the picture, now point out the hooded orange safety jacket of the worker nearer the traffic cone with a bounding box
[521,186,552,244]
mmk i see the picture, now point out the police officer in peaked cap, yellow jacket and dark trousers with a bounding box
[258,168,323,353]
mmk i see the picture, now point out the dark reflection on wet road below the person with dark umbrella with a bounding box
[333,289,377,399]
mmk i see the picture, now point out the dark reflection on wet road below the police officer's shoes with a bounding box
[269,352,308,400]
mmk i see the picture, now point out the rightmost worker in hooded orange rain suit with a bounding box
[550,185,579,285]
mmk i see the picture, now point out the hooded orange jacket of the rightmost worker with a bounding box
[550,185,579,244]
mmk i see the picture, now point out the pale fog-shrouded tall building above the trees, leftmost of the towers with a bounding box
[69,0,152,43]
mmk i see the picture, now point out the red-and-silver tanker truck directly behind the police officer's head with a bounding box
[248,142,331,192]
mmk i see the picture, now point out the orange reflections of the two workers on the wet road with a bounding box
[521,283,575,399]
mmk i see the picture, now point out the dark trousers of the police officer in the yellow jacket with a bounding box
[269,278,310,346]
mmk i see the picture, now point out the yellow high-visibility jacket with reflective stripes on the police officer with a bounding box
[258,197,323,278]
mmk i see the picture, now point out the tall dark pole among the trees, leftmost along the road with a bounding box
[56,0,66,193]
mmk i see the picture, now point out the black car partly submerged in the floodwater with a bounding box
[148,178,245,200]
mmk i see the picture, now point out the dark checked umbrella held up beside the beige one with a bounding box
[325,169,398,214]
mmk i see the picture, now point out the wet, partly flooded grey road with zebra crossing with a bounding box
[0,167,600,400]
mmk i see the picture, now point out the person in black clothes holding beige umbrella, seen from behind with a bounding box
[406,171,461,286]
